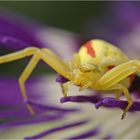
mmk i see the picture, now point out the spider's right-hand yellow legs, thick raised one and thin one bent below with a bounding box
[95,60,140,119]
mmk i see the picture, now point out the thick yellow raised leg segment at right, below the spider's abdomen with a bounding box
[96,60,140,89]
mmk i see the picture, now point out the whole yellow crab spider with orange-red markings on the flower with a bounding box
[0,39,140,119]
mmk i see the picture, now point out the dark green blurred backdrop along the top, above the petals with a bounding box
[0,1,106,36]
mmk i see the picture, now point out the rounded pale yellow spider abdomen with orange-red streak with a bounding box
[79,39,129,67]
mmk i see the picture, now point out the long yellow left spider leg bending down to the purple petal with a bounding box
[19,48,72,114]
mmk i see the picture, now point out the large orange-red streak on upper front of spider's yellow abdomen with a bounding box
[84,41,96,57]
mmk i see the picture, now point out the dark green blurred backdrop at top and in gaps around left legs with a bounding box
[0,1,110,76]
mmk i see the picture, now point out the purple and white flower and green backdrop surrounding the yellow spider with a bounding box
[0,1,140,139]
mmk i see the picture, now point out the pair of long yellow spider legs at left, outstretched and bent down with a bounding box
[0,47,71,114]
